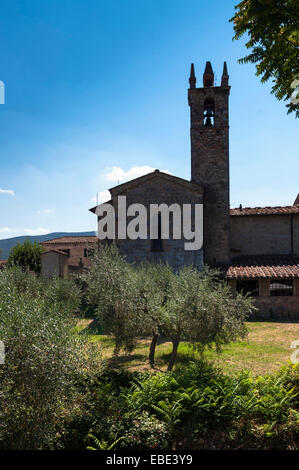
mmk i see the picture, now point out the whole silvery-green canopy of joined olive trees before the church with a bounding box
[82,244,254,370]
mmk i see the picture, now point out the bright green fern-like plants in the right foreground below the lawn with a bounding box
[127,361,299,434]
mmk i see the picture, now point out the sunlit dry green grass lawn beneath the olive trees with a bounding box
[76,319,299,375]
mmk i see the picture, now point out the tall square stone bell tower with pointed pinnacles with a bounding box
[188,62,230,266]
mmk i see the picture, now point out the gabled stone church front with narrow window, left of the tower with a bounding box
[97,170,203,268]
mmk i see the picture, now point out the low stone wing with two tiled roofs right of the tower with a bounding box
[226,204,299,319]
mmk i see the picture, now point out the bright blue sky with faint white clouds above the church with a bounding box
[0,0,299,238]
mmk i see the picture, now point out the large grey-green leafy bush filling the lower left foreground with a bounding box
[0,269,99,449]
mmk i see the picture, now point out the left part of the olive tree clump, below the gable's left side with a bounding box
[82,244,151,354]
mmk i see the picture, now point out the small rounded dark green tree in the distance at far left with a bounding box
[7,240,43,273]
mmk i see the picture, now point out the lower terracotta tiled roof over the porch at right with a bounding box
[226,255,299,279]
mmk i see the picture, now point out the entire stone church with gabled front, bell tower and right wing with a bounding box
[90,62,299,319]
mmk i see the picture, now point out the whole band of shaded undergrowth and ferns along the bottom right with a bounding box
[85,361,299,450]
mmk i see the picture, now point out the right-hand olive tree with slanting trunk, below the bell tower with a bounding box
[160,266,254,370]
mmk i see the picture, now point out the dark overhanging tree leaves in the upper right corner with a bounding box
[230,0,299,117]
